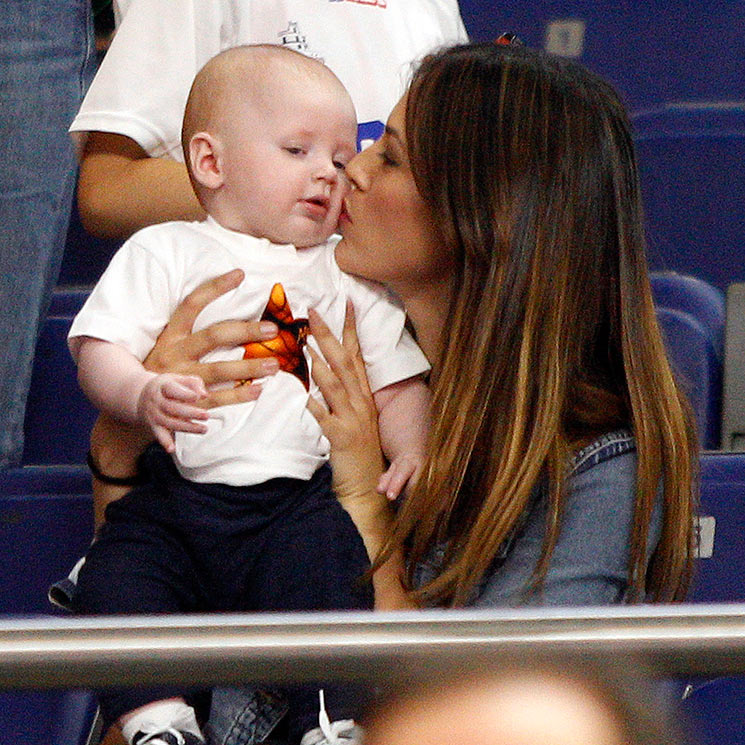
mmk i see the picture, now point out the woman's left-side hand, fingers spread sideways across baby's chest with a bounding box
[144,269,279,408]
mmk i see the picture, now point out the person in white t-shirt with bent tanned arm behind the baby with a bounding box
[72,0,466,238]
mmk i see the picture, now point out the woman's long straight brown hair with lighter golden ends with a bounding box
[388,44,697,605]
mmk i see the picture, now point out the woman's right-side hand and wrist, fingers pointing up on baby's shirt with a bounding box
[308,304,391,558]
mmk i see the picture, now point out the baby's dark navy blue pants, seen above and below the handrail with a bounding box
[75,445,373,739]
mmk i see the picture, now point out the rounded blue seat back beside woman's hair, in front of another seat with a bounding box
[657,307,722,449]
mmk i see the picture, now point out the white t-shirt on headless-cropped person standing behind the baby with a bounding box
[71,0,467,161]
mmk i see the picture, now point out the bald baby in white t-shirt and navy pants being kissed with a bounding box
[69,45,429,745]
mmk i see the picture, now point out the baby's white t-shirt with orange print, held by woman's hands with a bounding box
[69,218,429,485]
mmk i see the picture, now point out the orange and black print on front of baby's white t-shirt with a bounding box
[243,282,310,391]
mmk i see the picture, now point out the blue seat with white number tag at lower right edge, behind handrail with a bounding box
[683,453,745,745]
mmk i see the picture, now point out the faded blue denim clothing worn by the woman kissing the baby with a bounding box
[209,431,662,745]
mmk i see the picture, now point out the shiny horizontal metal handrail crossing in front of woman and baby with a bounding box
[0,604,745,689]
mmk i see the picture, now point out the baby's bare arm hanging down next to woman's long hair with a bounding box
[373,376,430,499]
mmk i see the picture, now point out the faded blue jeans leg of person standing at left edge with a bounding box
[0,0,94,466]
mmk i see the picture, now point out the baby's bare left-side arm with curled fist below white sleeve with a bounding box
[76,336,209,453]
